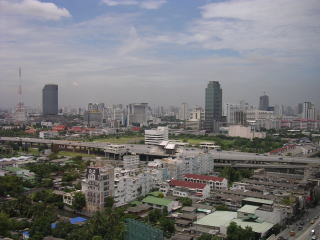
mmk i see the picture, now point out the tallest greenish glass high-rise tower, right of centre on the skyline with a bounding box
[204,81,222,132]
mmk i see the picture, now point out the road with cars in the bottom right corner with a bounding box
[277,206,320,240]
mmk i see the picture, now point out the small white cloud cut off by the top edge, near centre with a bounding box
[102,0,166,9]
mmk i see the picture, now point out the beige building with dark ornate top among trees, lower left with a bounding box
[81,166,114,212]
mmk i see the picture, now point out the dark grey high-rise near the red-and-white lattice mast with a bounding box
[42,84,58,115]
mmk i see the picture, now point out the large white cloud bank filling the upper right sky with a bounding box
[184,0,320,55]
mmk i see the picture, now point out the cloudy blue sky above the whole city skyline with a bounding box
[0,0,320,107]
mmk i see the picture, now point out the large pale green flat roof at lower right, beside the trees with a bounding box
[195,211,237,227]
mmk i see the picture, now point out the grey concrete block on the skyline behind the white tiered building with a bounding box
[127,103,149,126]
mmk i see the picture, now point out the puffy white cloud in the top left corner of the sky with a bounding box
[0,0,71,21]
